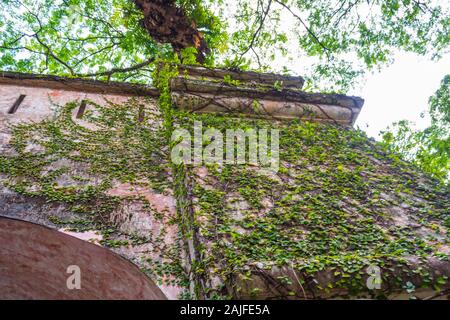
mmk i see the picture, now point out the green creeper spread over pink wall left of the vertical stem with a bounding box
[0,98,189,294]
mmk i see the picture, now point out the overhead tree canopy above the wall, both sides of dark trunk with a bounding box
[0,0,450,92]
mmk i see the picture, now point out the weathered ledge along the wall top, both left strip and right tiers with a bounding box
[0,66,364,126]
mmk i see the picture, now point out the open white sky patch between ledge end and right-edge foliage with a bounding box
[351,53,450,139]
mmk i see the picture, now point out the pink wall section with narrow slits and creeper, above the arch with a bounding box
[0,86,186,299]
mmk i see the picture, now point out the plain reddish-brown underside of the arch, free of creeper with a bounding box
[0,217,166,300]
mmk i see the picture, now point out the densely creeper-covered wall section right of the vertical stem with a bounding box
[180,115,450,299]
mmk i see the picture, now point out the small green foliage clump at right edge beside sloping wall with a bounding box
[382,75,450,183]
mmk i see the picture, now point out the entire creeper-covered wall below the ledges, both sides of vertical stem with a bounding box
[0,66,450,299]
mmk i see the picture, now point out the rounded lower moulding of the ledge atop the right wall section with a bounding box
[171,76,364,126]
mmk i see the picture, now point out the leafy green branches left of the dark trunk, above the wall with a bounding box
[0,0,168,80]
